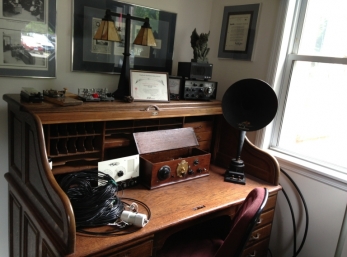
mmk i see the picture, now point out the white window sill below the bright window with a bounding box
[267,150,347,191]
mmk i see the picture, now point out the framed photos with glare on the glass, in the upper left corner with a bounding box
[0,0,56,78]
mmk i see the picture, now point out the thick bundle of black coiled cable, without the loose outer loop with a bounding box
[59,169,124,227]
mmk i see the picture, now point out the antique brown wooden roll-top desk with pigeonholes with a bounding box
[3,94,281,257]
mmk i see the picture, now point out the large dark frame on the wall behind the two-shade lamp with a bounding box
[71,0,177,74]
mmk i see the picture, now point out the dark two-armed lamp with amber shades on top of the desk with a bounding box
[93,9,156,99]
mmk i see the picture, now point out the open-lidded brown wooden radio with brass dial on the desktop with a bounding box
[134,128,211,189]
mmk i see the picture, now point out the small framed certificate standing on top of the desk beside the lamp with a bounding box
[130,70,170,102]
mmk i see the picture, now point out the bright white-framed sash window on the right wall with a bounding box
[270,0,347,178]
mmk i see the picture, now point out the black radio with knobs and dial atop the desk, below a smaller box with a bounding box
[181,80,218,100]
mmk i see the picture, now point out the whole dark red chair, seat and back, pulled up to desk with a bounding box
[156,187,268,257]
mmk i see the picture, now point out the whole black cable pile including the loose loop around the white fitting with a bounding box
[58,169,151,236]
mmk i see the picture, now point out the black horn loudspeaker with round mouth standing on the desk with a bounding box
[222,79,278,185]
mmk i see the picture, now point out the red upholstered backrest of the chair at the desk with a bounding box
[215,187,269,257]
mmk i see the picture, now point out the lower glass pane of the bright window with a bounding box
[278,61,347,168]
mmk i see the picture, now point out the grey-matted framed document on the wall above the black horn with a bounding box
[218,4,260,60]
